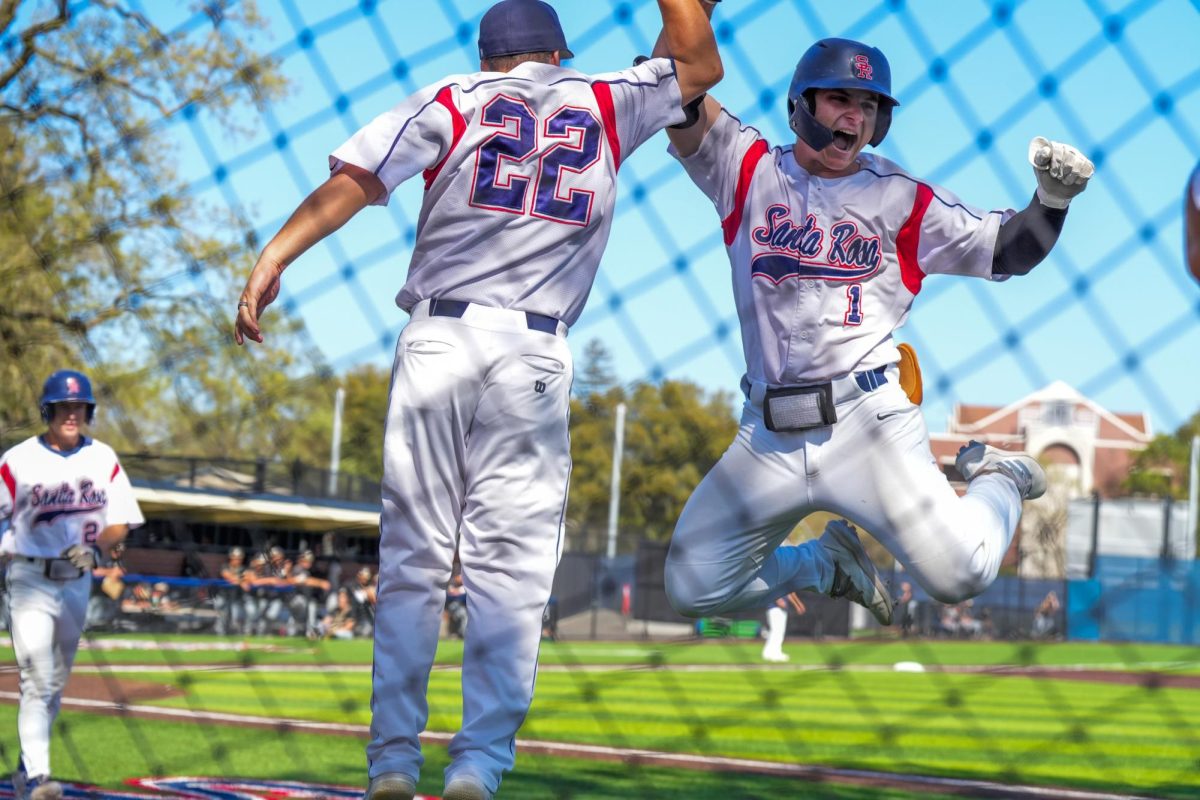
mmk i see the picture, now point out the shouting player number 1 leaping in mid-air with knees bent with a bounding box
[666,28,1092,625]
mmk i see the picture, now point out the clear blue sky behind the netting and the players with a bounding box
[159,0,1200,431]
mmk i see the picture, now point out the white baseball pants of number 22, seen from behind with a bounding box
[367,302,571,792]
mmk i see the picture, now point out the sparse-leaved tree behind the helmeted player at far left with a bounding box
[0,0,329,458]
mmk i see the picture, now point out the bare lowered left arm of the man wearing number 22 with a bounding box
[233,164,384,344]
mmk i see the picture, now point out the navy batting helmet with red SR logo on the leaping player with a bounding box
[787,38,900,150]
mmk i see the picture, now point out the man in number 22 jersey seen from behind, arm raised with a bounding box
[235,0,721,800]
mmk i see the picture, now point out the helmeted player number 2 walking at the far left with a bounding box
[0,369,144,800]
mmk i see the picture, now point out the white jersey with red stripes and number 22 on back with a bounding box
[329,59,683,325]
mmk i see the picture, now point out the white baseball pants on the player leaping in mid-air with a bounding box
[666,369,1021,616]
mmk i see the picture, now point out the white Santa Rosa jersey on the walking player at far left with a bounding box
[0,437,145,558]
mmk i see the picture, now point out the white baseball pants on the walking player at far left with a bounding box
[7,557,91,776]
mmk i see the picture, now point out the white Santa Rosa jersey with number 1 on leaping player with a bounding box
[671,110,1014,385]
